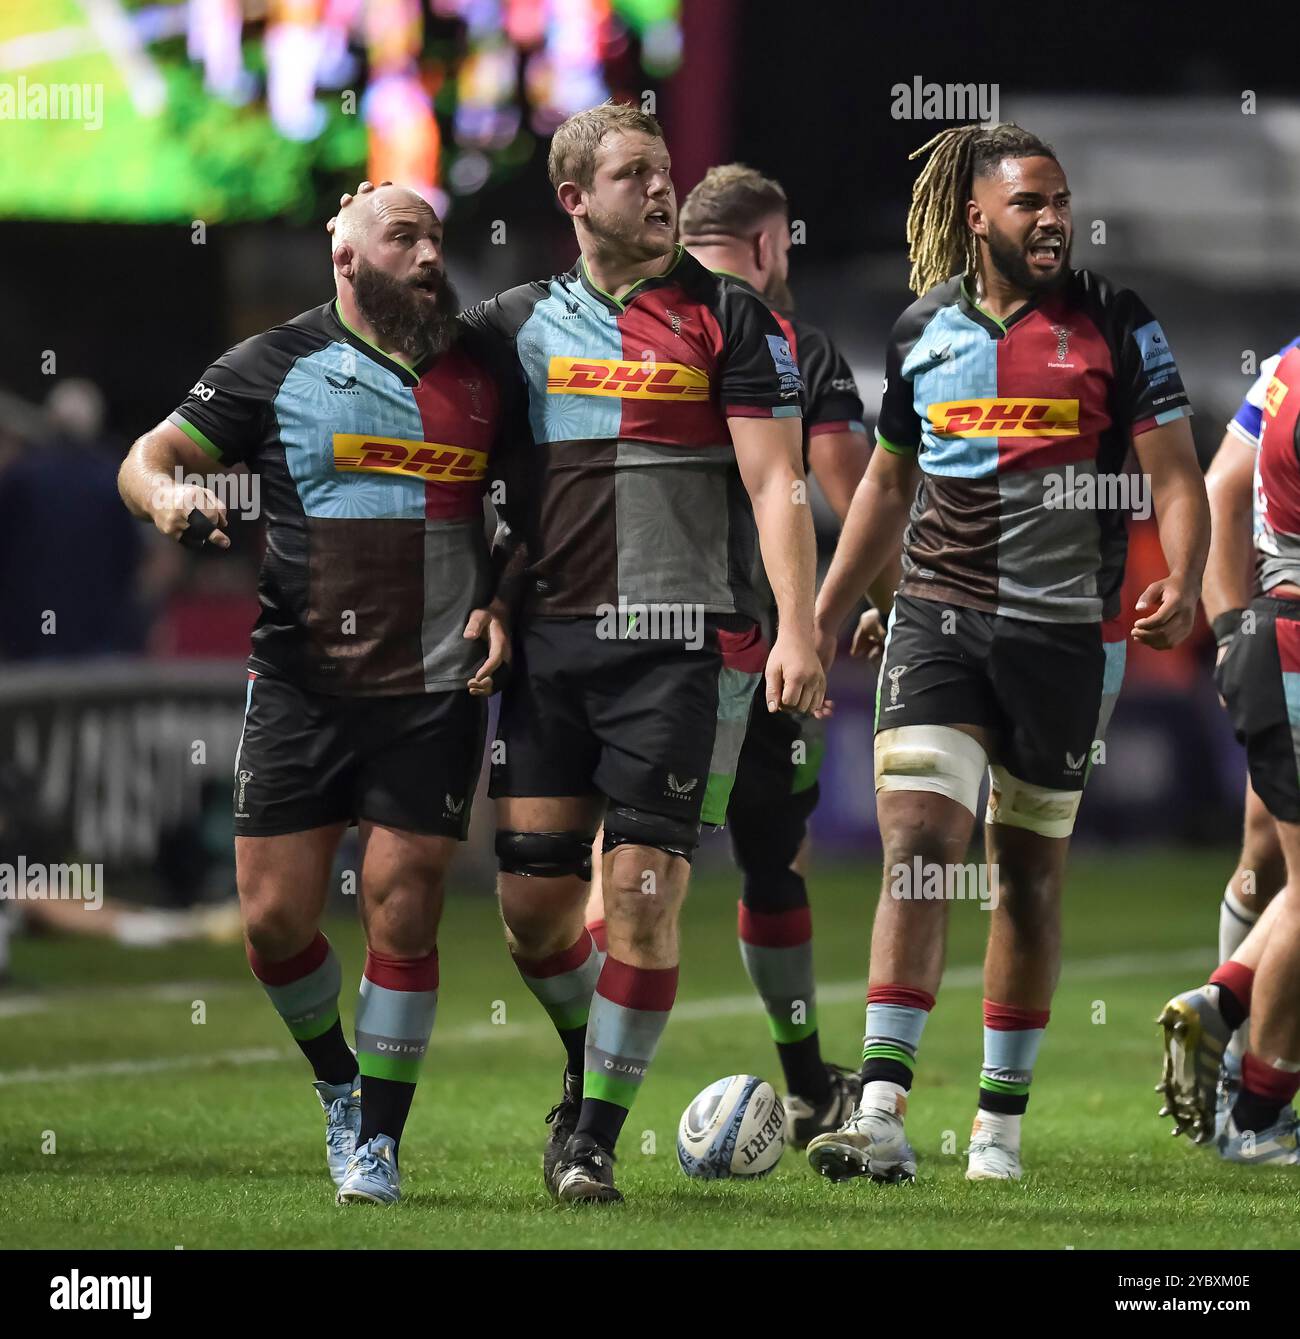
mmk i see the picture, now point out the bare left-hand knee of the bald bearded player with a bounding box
[234,823,344,963]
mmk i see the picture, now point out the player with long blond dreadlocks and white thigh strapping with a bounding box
[809,125,1209,1181]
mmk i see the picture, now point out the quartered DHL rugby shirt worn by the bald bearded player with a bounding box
[169,303,526,695]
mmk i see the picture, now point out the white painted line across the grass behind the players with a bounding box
[0,949,1213,1086]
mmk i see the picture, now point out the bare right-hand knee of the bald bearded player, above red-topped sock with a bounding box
[361,823,457,957]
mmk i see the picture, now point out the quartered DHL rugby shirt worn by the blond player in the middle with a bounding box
[466,246,802,620]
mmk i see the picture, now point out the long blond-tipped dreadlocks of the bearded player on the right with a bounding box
[908,121,1056,295]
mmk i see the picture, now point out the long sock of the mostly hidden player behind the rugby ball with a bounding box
[736,894,830,1106]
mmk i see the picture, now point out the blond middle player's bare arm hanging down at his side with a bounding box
[727,416,826,711]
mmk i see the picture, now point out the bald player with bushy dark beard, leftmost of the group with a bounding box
[119,186,526,1204]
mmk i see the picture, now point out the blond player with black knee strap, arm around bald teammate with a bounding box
[444,103,825,1201]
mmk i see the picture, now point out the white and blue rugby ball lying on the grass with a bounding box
[677,1074,786,1181]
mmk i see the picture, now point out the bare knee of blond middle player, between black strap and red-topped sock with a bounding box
[604,846,691,968]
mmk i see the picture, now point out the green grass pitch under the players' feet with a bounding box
[0,852,1279,1249]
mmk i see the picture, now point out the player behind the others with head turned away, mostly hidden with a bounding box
[586,163,897,1148]
